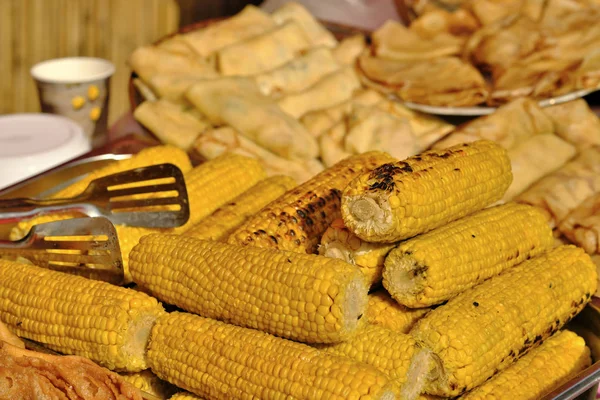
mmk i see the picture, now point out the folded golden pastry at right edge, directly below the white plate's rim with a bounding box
[543,99,600,148]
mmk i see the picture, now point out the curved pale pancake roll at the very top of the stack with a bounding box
[271,1,337,47]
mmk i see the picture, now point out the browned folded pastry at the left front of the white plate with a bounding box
[359,53,488,107]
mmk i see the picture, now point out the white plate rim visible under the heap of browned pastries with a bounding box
[390,87,600,117]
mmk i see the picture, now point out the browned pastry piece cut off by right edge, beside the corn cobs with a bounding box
[559,192,600,254]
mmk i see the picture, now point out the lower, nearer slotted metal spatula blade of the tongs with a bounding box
[0,217,123,285]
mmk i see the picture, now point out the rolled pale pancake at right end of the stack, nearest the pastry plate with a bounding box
[277,67,360,118]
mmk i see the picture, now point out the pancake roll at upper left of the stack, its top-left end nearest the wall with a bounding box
[182,5,276,57]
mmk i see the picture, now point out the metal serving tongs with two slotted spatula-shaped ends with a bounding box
[0,164,190,285]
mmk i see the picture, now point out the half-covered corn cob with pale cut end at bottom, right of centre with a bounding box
[317,325,426,400]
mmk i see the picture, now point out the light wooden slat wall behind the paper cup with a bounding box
[0,0,179,123]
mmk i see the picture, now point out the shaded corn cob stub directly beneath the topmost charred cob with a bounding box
[319,218,395,286]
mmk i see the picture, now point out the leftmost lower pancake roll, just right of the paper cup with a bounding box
[133,99,211,151]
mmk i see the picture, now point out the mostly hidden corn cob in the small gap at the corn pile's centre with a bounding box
[366,290,430,333]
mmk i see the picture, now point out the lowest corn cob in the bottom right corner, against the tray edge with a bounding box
[462,331,592,400]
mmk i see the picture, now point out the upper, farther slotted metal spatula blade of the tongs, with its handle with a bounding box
[0,164,190,228]
